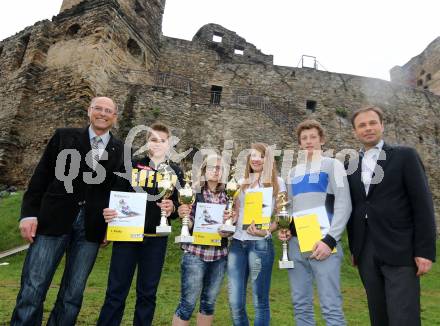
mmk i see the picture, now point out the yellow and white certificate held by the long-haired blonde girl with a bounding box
[243,187,273,230]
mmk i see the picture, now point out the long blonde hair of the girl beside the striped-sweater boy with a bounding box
[241,143,280,197]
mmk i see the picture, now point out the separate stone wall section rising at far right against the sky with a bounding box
[390,37,440,95]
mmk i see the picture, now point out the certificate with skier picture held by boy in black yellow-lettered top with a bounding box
[107,191,147,241]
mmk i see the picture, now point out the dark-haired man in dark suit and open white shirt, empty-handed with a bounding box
[347,106,436,326]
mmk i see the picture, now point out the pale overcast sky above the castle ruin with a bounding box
[0,0,440,80]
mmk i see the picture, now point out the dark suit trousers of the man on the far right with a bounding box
[358,230,421,326]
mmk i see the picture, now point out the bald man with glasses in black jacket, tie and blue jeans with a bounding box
[11,97,123,326]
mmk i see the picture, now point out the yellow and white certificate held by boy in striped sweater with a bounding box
[293,206,336,253]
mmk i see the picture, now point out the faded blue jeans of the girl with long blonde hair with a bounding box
[228,239,274,326]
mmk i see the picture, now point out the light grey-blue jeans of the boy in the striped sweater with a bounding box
[289,237,346,326]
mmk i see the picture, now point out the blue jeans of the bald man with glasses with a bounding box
[11,209,99,326]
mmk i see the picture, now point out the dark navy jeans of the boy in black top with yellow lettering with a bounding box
[98,237,168,326]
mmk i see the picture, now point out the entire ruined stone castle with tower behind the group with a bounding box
[0,0,440,229]
